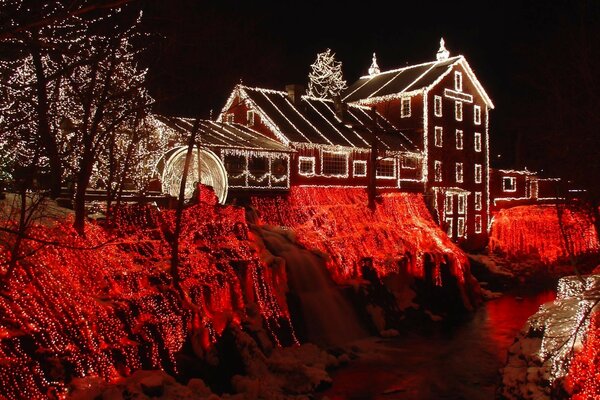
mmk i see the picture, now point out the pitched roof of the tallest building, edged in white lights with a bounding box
[342,56,494,108]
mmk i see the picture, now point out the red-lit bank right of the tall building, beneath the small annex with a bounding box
[490,205,600,263]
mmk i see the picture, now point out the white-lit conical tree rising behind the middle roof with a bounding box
[308,49,347,98]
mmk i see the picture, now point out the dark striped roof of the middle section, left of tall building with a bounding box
[219,85,417,151]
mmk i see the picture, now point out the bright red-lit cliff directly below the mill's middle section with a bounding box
[252,187,470,304]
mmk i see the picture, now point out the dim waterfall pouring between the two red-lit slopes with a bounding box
[255,223,368,346]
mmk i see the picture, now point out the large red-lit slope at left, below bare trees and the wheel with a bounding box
[0,192,289,399]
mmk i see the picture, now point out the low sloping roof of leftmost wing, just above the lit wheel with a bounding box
[156,115,292,152]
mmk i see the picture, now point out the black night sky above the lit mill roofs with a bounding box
[139,0,576,166]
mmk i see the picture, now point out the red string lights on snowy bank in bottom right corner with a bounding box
[566,312,600,400]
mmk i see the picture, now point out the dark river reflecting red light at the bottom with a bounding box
[319,291,555,400]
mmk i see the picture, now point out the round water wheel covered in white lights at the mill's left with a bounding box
[154,146,228,204]
